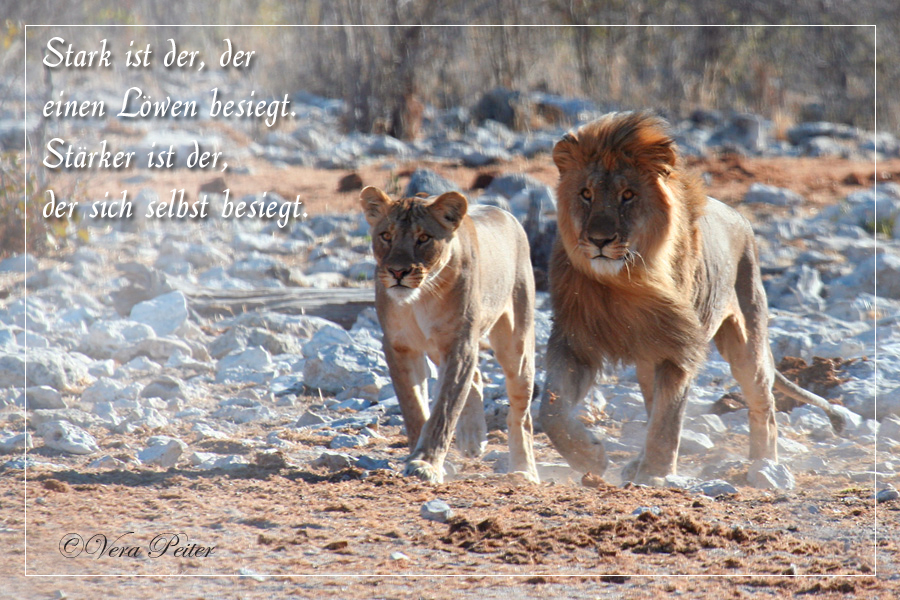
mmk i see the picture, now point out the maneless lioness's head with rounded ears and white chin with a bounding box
[360,186,468,303]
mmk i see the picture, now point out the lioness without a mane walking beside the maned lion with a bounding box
[360,186,538,483]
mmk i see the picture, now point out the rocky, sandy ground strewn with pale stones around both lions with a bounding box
[0,88,900,598]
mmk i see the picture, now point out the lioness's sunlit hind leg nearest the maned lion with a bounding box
[490,317,540,482]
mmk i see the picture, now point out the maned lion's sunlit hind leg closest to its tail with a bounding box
[715,318,778,460]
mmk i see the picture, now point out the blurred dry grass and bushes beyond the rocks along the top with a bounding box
[0,0,888,252]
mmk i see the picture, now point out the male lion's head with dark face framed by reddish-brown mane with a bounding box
[553,114,675,278]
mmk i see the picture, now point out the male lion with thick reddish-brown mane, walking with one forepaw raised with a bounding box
[540,113,839,484]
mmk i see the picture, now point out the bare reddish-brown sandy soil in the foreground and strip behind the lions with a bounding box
[8,157,900,599]
